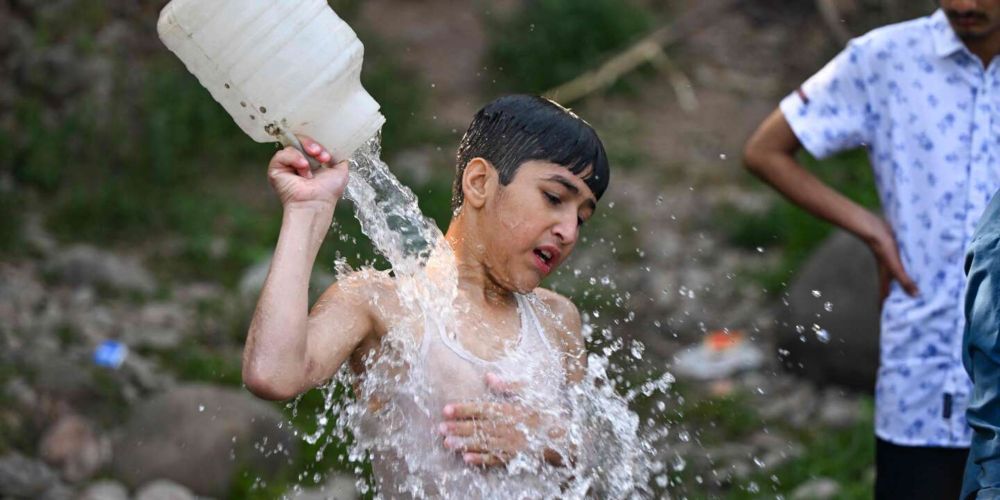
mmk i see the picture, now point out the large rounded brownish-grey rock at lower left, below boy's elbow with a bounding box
[113,384,294,498]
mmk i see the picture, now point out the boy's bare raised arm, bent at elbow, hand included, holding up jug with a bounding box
[243,138,372,400]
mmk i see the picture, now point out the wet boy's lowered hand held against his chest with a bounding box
[439,373,544,467]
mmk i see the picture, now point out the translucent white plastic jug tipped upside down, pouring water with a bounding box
[157,0,385,160]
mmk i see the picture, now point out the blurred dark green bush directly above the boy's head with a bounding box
[487,0,651,93]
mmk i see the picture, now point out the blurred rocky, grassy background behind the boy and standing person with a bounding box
[0,0,935,499]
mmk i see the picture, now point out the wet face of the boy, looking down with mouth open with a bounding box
[481,160,597,293]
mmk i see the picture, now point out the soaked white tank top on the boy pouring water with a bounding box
[363,294,566,499]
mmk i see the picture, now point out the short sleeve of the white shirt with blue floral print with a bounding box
[781,40,875,158]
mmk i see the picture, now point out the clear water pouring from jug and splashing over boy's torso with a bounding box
[278,136,673,498]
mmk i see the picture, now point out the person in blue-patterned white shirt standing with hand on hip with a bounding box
[744,0,1000,500]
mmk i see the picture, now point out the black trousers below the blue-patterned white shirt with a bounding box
[875,438,969,500]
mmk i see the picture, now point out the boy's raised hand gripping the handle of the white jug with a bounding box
[267,136,348,208]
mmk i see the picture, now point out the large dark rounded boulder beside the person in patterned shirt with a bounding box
[778,232,880,391]
